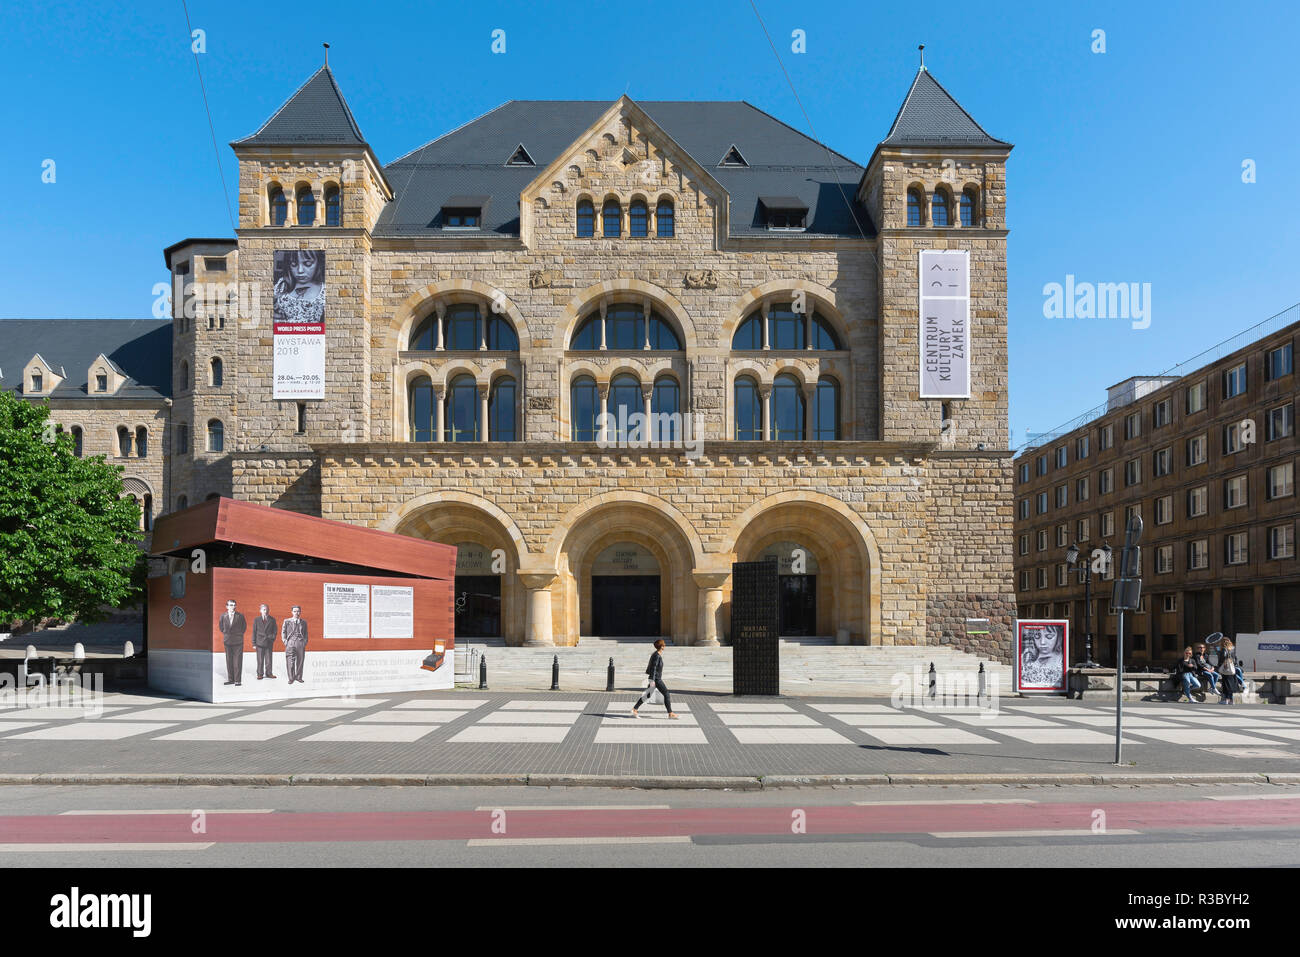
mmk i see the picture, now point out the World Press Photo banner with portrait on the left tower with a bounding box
[272,250,325,399]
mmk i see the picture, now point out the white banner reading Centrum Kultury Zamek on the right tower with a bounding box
[918,250,971,399]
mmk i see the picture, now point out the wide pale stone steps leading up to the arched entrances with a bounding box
[458,637,1011,697]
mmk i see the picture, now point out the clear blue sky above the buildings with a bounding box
[0,0,1300,443]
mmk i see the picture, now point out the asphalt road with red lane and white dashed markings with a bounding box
[0,785,1300,878]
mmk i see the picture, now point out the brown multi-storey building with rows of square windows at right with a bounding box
[1015,316,1300,663]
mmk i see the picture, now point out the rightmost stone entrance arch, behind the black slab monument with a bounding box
[728,493,880,644]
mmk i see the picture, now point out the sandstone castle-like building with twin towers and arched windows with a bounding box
[94,68,1015,659]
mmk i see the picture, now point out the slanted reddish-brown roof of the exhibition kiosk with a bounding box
[152,498,456,579]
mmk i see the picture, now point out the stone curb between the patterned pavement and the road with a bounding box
[0,771,1300,791]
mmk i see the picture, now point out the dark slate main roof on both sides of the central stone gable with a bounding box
[374,100,875,238]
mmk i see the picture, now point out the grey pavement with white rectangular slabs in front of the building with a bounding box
[0,692,1300,775]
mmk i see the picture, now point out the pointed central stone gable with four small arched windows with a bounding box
[519,96,728,248]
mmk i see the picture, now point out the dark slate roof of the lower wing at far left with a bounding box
[0,319,172,402]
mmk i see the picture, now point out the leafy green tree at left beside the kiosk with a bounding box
[0,391,147,625]
